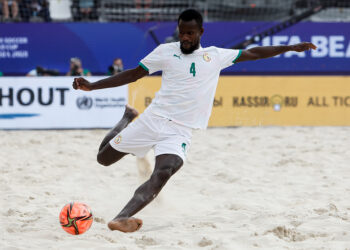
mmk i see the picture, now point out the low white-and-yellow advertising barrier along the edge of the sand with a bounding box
[0,76,350,129]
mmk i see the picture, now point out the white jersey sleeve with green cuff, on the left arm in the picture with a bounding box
[139,45,164,74]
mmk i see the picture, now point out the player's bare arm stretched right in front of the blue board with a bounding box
[236,42,316,62]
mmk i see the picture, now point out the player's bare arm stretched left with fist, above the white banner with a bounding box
[73,66,148,91]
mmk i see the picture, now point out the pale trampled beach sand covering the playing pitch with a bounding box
[0,127,350,250]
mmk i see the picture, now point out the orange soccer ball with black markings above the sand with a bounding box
[59,202,93,234]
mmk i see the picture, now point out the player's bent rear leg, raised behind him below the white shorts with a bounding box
[97,105,139,166]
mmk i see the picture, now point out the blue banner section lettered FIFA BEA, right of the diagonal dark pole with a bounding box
[230,22,350,75]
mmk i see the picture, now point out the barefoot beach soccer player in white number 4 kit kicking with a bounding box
[73,9,316,232]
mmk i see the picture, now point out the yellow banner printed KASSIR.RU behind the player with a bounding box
[129,76,350,127]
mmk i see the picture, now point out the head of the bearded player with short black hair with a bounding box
[177,9,204,54]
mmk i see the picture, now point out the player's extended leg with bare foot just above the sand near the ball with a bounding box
[108,154,183,232]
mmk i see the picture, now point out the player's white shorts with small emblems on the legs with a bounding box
[109,111,192,162]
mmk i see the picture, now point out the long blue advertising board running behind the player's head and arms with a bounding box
[0,22,350,75]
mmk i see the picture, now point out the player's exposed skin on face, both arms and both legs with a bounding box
[73,20,316,232]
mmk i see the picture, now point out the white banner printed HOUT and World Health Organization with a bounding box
[0,77,128,129]
